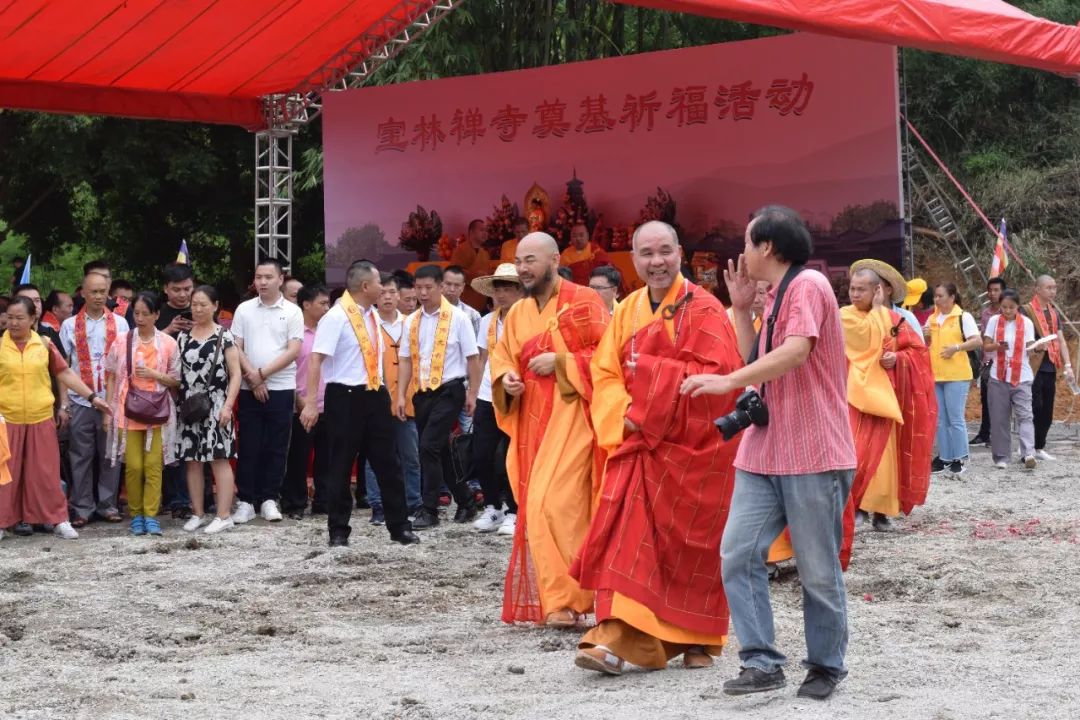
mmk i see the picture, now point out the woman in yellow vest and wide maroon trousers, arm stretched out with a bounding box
[0,298,110,540]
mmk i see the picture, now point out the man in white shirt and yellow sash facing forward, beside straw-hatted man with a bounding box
[397,266,482,530]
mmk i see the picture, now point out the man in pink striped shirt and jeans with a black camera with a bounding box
[683,205,855,699]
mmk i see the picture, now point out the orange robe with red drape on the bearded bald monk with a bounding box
[490,280,611,623]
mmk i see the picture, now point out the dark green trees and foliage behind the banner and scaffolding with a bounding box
[0,0,1080,297]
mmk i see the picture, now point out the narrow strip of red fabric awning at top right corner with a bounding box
[615,0,1080,76]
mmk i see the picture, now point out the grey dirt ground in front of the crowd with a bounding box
[0,426,1080,720]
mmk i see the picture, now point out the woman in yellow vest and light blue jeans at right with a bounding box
[922,283,982,475]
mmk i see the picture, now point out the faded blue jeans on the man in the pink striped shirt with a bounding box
[720,470,854,679]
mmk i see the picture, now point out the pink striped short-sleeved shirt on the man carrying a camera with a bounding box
[735,270,855,475]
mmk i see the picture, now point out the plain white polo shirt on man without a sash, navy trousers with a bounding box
[231,295,303,390]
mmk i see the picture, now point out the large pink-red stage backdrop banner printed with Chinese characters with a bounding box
[323,33,903,283]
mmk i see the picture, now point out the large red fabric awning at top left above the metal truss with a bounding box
[0,0,435,130]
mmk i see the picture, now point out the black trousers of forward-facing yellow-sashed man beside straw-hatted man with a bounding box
[412,380,472,513]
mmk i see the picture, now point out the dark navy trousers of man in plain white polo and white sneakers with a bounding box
[237,390,296,513]
